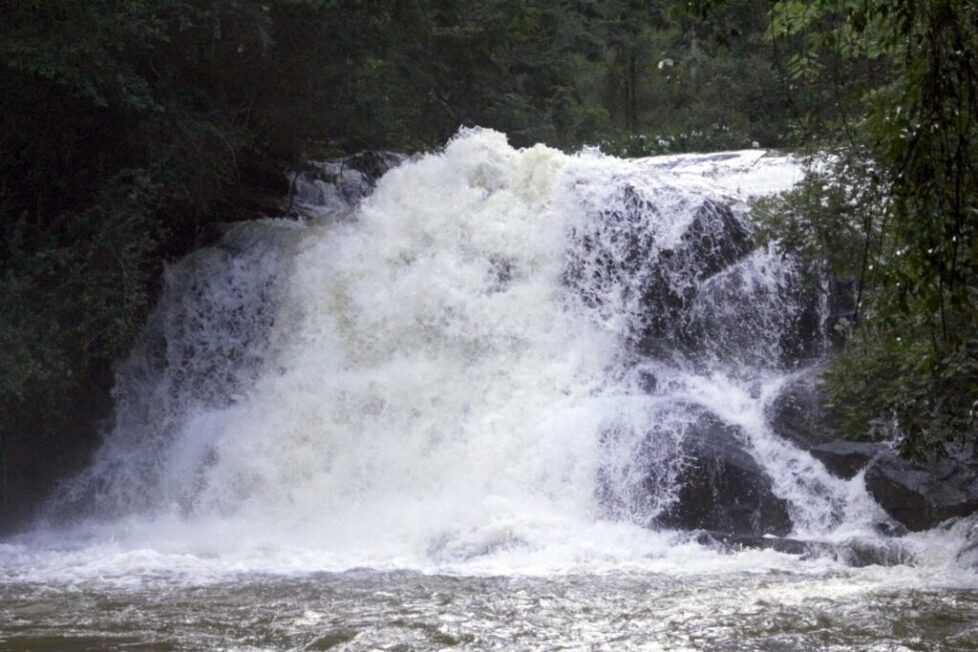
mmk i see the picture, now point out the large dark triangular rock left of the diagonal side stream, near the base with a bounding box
[656,415,792,536]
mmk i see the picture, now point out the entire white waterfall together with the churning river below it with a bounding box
[0,130,978,650]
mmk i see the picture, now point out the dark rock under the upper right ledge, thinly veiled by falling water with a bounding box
[635,201,825,368]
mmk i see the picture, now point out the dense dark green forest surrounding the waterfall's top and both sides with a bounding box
[0,0,978,527]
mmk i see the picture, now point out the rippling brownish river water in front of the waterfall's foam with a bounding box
[0,567,978,651]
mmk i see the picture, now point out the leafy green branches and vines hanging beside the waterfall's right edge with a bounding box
[769,0,978,455]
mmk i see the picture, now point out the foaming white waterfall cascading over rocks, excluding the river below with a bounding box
[40,130,908,567]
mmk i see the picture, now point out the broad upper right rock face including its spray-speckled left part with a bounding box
[565,191,824,368]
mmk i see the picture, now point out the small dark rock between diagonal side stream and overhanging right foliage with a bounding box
[767,367,839,450]
